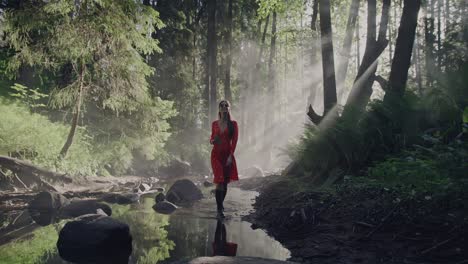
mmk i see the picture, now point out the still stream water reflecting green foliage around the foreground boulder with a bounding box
[0,188,290,264]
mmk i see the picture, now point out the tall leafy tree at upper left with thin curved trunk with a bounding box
[5,0,161,158]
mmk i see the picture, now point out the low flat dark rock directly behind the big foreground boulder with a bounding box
[60,200,112,218]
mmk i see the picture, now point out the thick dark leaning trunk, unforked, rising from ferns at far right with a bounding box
[384,0,421,100]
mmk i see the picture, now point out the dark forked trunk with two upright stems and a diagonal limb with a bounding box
[346,0,390,111]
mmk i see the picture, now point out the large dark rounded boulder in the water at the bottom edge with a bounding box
[57,214,132,263]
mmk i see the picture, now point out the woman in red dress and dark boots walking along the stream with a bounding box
[210,100,239,218]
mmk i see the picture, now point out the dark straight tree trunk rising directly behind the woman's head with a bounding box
[207,0,218,123]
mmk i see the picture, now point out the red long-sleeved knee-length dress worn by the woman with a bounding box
[210,120,239,183]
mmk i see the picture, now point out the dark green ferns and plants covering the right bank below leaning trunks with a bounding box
[291,83,466,188]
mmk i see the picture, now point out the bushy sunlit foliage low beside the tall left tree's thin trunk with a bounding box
[88,98,177,175]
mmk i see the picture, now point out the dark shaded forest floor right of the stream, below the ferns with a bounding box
[236,176,468,264]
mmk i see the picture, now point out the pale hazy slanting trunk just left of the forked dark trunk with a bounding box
[337,0,359,101]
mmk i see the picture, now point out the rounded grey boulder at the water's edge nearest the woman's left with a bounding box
[166,179,203,205]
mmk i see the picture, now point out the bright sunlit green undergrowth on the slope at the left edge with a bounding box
[0,97,98,175]
